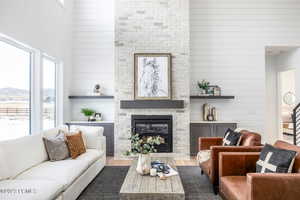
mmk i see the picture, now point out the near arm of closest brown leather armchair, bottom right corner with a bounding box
[247,173,300,200]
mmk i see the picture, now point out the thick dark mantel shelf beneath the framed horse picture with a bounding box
[120,100,184,109]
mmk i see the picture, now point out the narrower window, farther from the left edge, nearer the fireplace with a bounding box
[42,56,57,130]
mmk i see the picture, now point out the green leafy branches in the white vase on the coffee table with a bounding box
[125,134,164,156]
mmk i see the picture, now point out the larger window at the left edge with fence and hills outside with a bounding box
[0,40,32,140]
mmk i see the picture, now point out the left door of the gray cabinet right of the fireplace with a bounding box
[190,123,213,156]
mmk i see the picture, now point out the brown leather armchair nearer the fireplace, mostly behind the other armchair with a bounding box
[198,130,262,194]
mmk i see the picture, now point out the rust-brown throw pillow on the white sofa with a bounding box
[66,132,86,159]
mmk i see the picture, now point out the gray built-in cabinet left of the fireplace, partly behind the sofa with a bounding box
[66,122,115,156]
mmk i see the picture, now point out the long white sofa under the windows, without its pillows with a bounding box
[0,127,106,200]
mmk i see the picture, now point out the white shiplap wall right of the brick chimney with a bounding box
[190,0,300,141]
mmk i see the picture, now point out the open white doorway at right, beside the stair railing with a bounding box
[265,46,300,143]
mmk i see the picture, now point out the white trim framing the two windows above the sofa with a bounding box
[0,33,64,138]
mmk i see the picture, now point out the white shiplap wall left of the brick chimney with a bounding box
[70,0,114,121]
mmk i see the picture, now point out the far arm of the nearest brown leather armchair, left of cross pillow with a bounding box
[219,152,260,177]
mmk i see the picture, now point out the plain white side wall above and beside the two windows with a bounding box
[0,0,73,120]
